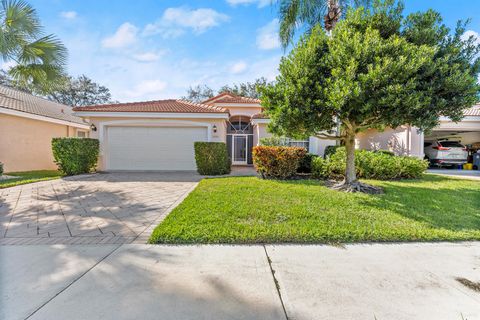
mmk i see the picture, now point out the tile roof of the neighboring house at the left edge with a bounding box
[0,85,87,124]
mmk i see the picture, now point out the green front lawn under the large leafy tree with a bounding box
[150,175,480,243]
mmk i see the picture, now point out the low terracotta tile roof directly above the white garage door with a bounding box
[73,99,228,113]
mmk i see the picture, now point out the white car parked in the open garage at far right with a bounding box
[424,140,468,167]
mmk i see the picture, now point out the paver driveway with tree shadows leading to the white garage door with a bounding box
[0,172,200,244]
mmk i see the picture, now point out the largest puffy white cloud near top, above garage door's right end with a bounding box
[144,7,230,38]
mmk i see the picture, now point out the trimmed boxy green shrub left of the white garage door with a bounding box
[52,138,99,175]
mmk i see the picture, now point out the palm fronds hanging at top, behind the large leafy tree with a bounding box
[279,0,371,48]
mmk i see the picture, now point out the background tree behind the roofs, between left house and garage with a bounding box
[47,75,112,107]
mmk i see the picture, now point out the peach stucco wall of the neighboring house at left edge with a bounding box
[0,114,77,172]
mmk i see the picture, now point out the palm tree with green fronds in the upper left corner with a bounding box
[0,0,67,92]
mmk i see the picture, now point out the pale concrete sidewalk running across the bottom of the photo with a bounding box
[0,242,480,320]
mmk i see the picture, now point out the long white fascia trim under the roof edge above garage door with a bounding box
[74,111,228,119]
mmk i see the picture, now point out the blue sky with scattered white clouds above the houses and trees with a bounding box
[23,0,480,102]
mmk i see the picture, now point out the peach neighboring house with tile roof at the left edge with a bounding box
[0,86,90,172]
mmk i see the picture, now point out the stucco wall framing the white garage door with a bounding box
[88,117,227,170]
